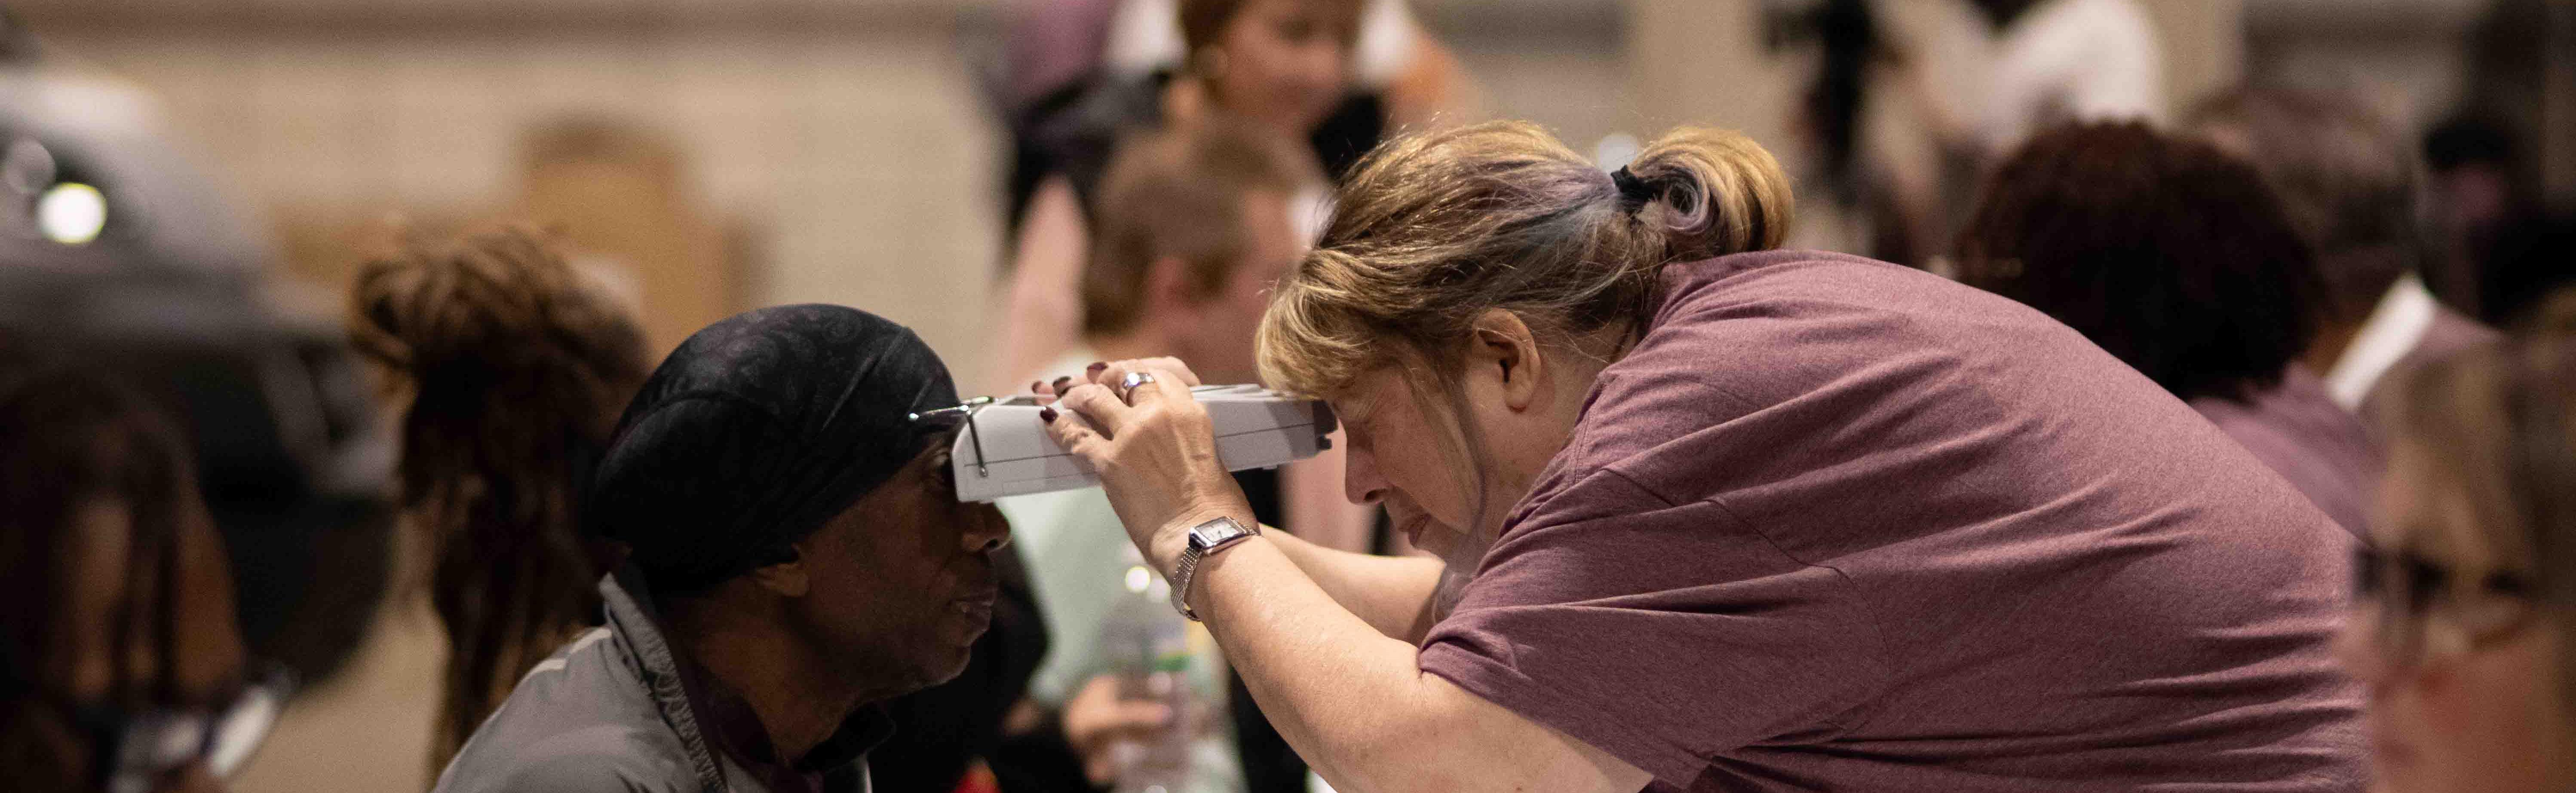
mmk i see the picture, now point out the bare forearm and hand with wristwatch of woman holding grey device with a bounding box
[1049,361,1649,793]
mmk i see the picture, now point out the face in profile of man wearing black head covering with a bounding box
[801,435,1010,690]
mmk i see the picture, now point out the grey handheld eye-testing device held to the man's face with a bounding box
[927,386,1334,502]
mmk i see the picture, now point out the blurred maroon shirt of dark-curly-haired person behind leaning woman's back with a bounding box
[2192,363,2380,538]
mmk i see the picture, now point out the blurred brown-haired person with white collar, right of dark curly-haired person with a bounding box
[2184,88,2496,417]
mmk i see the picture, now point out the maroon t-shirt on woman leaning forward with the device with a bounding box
[1420,252,2362,793]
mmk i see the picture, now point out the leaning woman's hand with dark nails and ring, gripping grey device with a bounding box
[1041,358,1252,574]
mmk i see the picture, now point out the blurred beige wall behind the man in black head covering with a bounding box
[34,3,1000,381]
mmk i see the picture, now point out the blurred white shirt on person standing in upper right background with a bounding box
[1978,0,2166,154]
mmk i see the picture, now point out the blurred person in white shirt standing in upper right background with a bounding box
[1770,0,2166,273]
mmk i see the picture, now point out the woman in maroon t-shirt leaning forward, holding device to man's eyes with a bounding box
[1049,124,2362,790]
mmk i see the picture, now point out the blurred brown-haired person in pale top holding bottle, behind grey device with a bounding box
[1000,119,1322,793]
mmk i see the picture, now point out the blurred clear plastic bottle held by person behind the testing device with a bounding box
[1100,551,1195,793]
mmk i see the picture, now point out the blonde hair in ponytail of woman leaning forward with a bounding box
[1260,121,1793,397]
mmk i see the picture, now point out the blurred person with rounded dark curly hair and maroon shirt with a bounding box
[1958,121,2380,536]
